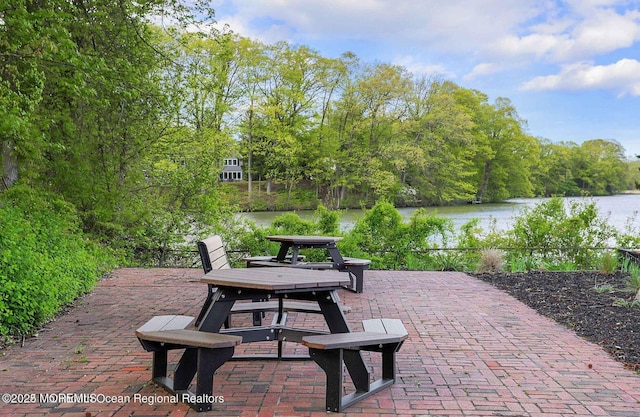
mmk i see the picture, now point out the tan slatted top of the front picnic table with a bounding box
[200,268,350,293]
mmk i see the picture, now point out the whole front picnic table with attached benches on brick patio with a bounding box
[136,268,407,412]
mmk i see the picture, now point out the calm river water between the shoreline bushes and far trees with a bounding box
[241,194,640,231]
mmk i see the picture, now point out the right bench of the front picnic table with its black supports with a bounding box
[302,319,408,412]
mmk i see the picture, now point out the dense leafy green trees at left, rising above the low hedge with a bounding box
[0,0,232,256]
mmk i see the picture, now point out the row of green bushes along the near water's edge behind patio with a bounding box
[232,198,640,272]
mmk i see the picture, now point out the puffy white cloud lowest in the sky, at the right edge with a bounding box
[522,59,640,96]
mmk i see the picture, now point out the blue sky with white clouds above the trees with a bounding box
[212,0,640,156]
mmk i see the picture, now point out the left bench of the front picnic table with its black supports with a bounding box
[136,316,242,411]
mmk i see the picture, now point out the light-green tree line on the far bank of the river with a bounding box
[166,33,631,208]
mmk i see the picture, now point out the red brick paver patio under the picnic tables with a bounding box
[0,269,640,417]
